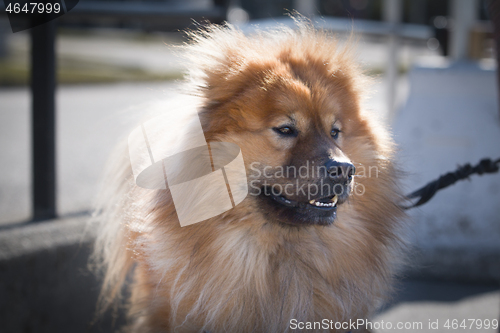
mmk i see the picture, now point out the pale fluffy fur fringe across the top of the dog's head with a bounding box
[184,16,369,101]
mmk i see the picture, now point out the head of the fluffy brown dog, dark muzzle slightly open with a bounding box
[189,25,392,225]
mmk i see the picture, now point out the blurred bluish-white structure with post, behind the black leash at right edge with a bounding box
[394,0,500,281]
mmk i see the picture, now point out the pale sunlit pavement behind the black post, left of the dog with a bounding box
[0,83,185,223]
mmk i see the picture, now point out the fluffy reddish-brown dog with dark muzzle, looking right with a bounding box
[95,23,403,333]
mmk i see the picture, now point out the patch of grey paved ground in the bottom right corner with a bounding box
[371,279,500,333]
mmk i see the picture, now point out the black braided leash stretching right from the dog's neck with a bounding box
[403,158,500,209]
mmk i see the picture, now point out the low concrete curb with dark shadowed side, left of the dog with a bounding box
[0,216,121,333]
